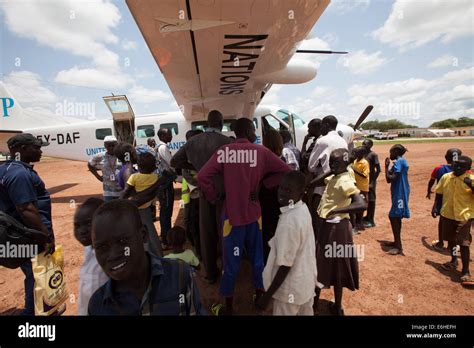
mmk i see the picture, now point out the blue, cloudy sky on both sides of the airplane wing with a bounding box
[0,0,474,127]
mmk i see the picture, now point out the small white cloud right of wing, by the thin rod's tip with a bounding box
[337,50,389,75]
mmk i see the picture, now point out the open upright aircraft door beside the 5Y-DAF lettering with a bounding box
[102,95,135,146]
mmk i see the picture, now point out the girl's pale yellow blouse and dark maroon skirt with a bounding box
[316,172,360,290]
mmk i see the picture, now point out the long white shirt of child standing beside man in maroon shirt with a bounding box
[263,201,318,305]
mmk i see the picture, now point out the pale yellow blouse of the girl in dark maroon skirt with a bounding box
[318,172,360,219]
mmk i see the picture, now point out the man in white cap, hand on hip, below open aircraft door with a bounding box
[87,135,122,202]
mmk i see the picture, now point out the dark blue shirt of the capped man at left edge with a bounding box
[0,161,53,234]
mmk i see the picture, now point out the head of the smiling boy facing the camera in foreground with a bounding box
[92,199,146,280]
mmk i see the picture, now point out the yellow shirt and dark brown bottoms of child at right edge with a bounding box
[436,173,474,246]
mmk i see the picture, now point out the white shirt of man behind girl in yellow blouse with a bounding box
[308,131,347,195]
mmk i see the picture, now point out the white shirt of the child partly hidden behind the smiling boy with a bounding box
[77,246,109,315]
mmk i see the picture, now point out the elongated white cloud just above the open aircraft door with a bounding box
[55,66,132,89]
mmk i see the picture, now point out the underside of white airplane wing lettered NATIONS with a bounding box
[127,0,330,120]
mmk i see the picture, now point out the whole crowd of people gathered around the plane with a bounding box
[0,110,474,316]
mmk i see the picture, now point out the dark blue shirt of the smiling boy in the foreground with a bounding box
[88,253,206,316]
